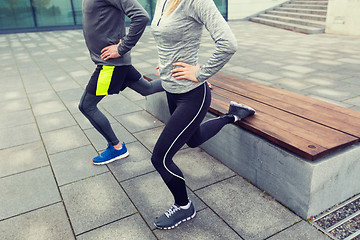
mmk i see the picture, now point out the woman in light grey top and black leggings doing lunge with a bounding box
[151,0,255,229]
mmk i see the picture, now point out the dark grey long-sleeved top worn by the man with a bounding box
[82,0,149,66]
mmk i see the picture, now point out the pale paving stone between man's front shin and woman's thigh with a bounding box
[115,111,164,133]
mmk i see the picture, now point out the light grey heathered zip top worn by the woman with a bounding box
[151,0,237,93]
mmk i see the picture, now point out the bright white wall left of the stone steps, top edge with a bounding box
[228,0,287,20]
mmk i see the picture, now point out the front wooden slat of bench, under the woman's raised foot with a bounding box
[210,88,358,160]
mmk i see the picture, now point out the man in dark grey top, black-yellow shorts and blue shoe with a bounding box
[79,0,163,165]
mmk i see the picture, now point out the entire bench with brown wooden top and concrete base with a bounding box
[146,73,360,218]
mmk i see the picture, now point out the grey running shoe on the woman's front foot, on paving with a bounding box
[154,201,196,230]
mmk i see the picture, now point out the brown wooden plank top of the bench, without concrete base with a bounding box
[210,73,360,161]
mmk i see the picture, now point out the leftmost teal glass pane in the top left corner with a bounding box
[0,0,35,29]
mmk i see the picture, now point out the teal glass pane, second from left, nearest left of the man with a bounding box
[31,0,74,27]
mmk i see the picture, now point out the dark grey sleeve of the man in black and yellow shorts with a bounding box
[109,0,149,56]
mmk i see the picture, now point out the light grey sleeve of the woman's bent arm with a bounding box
[191,0,237,82]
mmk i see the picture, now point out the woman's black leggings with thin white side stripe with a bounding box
[151,83,234,206]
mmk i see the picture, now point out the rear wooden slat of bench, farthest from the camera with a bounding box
[210,73,360,137]
